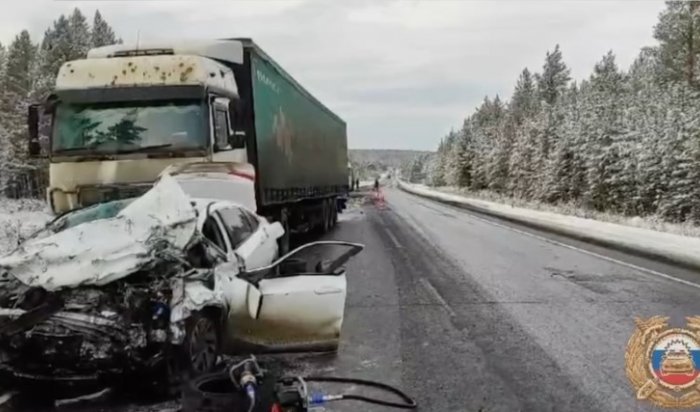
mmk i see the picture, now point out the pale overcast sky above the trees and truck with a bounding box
[0,0,664,150]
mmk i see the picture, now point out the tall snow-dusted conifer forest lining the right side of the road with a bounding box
[406,1,700,223]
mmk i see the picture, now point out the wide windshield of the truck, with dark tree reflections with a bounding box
[52,100,207,154]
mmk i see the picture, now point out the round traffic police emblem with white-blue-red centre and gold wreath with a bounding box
[625,316,700,408]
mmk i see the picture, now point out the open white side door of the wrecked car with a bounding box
[233,241,364,352]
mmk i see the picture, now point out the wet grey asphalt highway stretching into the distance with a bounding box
[12,189,700,412]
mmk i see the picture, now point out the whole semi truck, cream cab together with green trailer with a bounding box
[28,38,350,251]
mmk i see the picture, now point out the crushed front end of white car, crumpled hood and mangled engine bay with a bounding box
[0,175,226,392]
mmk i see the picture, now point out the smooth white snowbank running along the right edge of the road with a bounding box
[401,183,700,268]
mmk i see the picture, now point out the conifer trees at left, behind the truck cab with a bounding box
[0,8,120,198]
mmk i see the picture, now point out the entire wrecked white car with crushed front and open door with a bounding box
[0,175,363,392]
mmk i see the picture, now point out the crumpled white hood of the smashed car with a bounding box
[0,175,197,290]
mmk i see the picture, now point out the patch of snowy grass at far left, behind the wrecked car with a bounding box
[0,199,52,255]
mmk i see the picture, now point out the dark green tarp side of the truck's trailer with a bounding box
[244,43,348,206]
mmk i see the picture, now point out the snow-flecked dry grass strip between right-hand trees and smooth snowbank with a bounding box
[432,184,700,237]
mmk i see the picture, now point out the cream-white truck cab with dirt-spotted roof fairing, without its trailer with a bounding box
[29,40,248,213]
